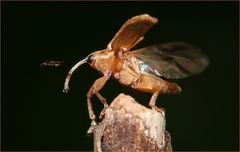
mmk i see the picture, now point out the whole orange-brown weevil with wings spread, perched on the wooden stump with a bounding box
[64,14,208,132]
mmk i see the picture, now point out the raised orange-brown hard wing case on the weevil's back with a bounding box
[107,14,158,51]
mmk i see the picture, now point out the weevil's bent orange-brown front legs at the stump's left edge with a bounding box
[87,74,111,134]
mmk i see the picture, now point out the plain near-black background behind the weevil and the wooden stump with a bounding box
[1,2,239,151]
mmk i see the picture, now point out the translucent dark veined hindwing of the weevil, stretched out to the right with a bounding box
[133,42,209,79]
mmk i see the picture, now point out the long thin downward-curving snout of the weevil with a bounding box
[63,57,88,93]
